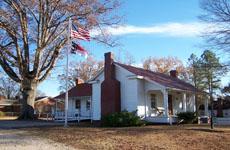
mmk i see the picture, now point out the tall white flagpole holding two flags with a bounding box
[64,18,71,127]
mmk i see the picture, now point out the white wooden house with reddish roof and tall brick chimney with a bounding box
[56,52,196,123]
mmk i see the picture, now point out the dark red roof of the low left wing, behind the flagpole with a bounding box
[54,83,92,99]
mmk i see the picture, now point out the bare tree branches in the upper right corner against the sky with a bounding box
[200,0,230,52]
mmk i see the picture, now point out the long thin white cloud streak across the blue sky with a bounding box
[92,22,213,37]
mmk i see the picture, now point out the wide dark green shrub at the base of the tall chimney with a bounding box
[102,111,143,127]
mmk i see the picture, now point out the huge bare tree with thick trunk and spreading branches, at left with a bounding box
[0,0,120,119]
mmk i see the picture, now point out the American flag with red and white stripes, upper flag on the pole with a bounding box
[71,25,90,41]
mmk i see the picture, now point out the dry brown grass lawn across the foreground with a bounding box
[29,125,230,150]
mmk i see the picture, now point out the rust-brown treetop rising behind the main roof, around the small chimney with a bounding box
[143,56,188,80]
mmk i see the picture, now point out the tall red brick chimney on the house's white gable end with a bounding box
[101,52,121,116]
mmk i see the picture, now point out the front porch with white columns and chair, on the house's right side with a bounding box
[140,89,195,124]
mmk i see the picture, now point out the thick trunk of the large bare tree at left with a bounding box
[18,80,38,120]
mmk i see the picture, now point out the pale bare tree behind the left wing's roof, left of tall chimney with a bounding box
[58,56,104,91]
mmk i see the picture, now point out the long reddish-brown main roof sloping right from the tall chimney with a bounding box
[115,62,196,92]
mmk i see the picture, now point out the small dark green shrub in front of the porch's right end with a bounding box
[177,112,197,123]
